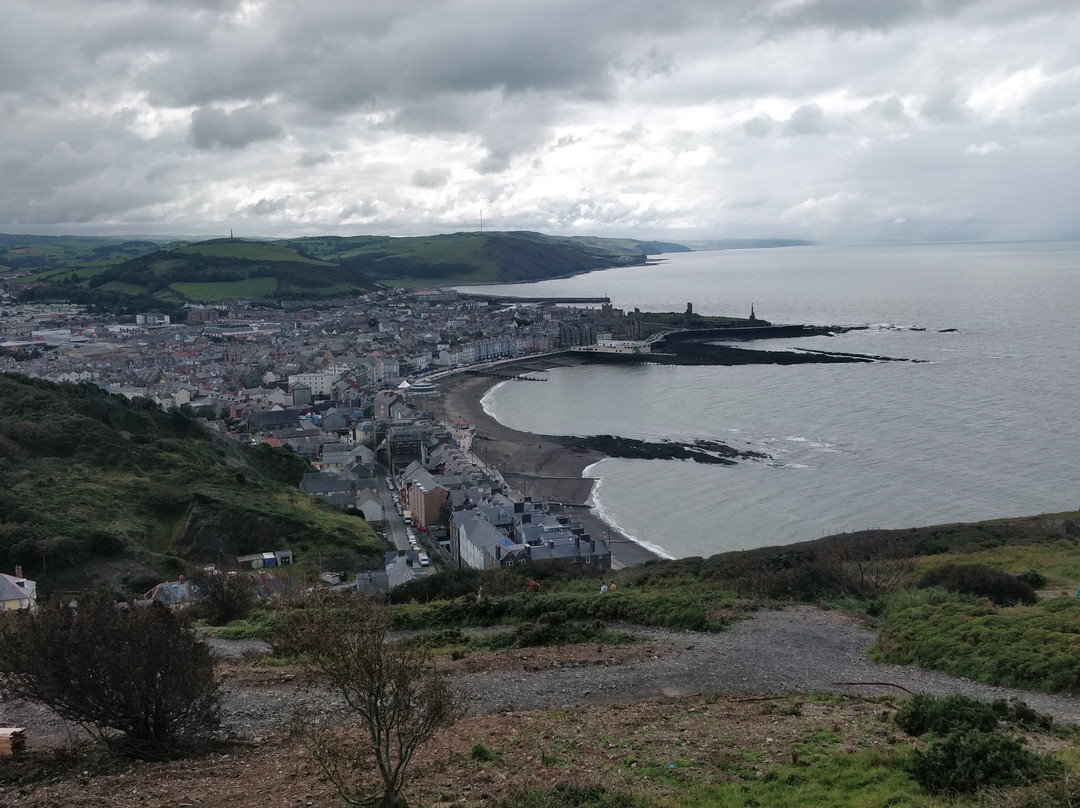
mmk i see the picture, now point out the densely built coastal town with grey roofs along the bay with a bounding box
[0,288,656,592]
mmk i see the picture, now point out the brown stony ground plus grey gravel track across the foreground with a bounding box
[0,607,1080,808]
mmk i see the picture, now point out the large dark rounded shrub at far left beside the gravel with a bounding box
[0,597,219,758]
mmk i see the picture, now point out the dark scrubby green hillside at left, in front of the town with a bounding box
[0,374,384,593]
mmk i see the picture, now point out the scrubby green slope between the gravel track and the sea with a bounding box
[375,512,1080,692]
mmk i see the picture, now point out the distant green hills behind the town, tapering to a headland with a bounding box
[8,232,687,311]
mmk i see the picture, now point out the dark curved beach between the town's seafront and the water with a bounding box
[432,358,659,569]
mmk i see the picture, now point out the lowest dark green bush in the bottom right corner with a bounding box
[907,729,1064,794]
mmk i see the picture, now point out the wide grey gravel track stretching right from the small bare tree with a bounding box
[451,607,1080,724]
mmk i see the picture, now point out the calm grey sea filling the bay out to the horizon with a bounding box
[469,242,1080,557]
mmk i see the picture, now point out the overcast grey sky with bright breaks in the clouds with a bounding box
[0,0,1080,241]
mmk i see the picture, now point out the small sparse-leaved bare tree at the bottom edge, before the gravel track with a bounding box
[276,592,462,808]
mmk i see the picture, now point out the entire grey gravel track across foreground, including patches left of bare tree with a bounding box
[8,606,1080,746]
